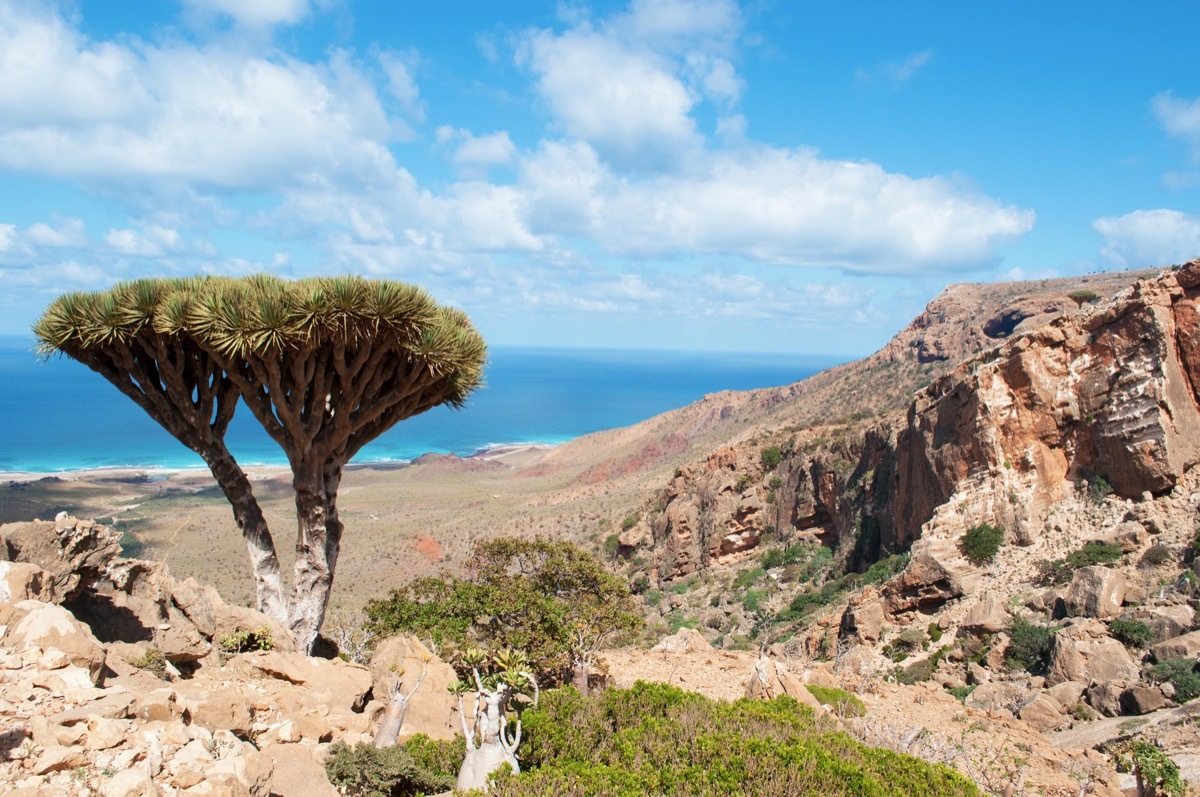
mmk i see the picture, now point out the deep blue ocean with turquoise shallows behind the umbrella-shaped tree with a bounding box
[0,336,842,473]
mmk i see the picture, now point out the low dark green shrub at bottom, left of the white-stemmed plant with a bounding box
[325,742,461,797]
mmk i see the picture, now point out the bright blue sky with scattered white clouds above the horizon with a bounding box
[0,0,1200,355]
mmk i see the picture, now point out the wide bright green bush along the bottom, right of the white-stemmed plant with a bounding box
[488,683,979,797]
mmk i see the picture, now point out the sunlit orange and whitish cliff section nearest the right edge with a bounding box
[883,262,1200,549]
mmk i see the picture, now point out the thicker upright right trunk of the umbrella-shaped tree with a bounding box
[288,468,341,655]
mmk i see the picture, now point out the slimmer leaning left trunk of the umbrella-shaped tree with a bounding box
[200,451,288,625]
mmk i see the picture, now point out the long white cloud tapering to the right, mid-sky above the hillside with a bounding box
[521,145,1034,274]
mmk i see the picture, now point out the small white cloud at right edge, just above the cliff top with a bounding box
[1092,208,1200,269]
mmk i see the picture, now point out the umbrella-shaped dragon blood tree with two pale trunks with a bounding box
[34,275,487,653]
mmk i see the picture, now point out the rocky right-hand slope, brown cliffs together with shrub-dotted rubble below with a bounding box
[622,262,1200,792]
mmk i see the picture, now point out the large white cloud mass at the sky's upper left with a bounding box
[0,4,395,190]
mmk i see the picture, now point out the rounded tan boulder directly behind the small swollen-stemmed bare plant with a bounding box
[370,635,458,739]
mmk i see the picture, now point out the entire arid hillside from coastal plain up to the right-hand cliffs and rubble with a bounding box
[0,262,1200,795]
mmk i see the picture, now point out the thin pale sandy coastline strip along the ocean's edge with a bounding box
[0,443,560,485]
